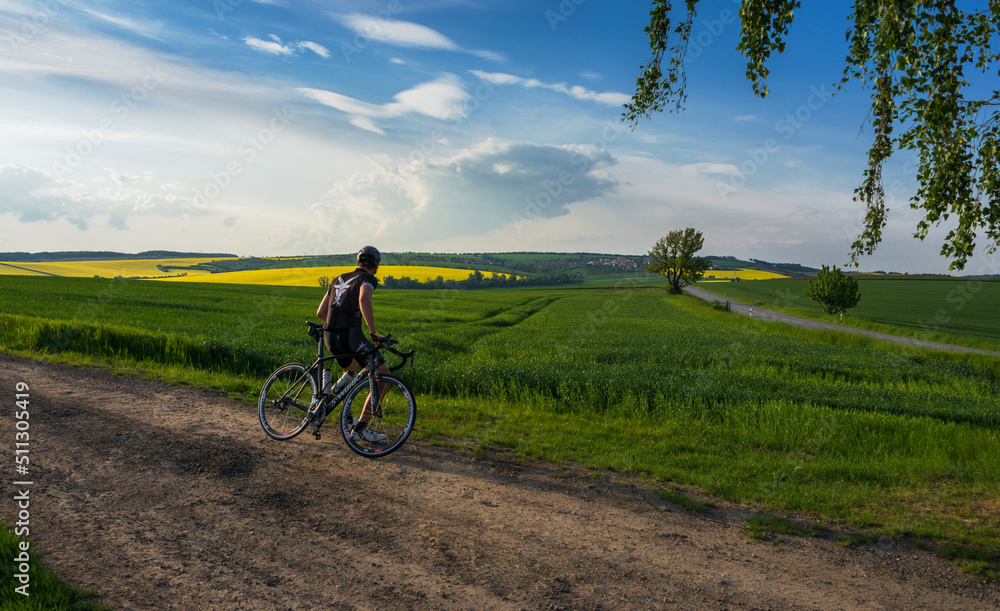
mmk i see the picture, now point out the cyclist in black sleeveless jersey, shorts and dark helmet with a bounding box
[316,246,389,443]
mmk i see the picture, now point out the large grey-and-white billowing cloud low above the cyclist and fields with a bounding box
[312,139,619,249]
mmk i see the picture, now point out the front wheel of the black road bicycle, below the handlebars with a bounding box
[340,375,417,458]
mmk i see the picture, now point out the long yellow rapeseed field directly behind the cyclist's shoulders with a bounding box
[154,265,489,287]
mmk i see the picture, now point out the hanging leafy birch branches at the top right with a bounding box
[623,0,1000,270]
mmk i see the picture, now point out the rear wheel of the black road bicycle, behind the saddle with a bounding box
[257,363,318,440]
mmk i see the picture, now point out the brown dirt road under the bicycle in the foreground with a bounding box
[0,356,1000,611]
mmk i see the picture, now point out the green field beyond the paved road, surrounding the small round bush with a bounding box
[698,278,1000,350]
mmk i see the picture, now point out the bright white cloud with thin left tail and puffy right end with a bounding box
[297,74,469,134]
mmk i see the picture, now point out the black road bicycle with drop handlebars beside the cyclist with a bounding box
[257,320,417,458]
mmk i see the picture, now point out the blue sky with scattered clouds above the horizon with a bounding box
[0,0,997,273]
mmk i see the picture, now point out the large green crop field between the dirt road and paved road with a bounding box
[0,276,1000,575]
